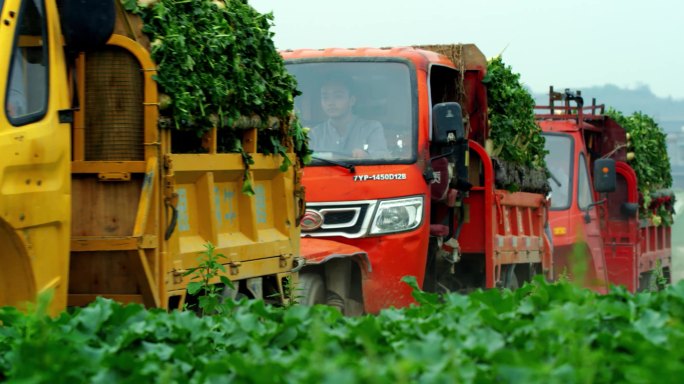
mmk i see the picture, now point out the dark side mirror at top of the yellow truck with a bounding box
[60,0,119,52]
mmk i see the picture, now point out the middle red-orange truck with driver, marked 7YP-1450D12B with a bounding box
[281,45,552,315]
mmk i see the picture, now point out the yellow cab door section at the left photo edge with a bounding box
[0,0,71,308]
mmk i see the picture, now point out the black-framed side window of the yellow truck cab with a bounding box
[5,0,48,126]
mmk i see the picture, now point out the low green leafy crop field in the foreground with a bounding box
[0,279,684,384]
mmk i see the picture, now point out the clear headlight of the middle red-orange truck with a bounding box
[370,196,423,235]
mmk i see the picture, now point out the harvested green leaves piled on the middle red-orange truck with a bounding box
[482,56,546,180]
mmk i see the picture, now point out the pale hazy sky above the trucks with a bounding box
[249,0,684,99]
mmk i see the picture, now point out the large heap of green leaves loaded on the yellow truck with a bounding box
[120,0,310,165]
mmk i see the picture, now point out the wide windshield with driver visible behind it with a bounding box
[287,61,416,165]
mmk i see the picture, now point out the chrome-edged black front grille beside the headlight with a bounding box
[302,200,376,238]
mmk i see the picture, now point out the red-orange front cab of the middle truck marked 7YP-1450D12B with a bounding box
[284,50,430,312]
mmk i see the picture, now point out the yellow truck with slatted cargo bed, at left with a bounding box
[0,0,303,313]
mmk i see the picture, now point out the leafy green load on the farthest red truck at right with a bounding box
[606,108,674,224]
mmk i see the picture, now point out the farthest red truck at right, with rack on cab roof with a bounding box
[536,87,671,292]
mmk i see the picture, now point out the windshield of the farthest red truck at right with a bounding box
[544,133,574,210]
